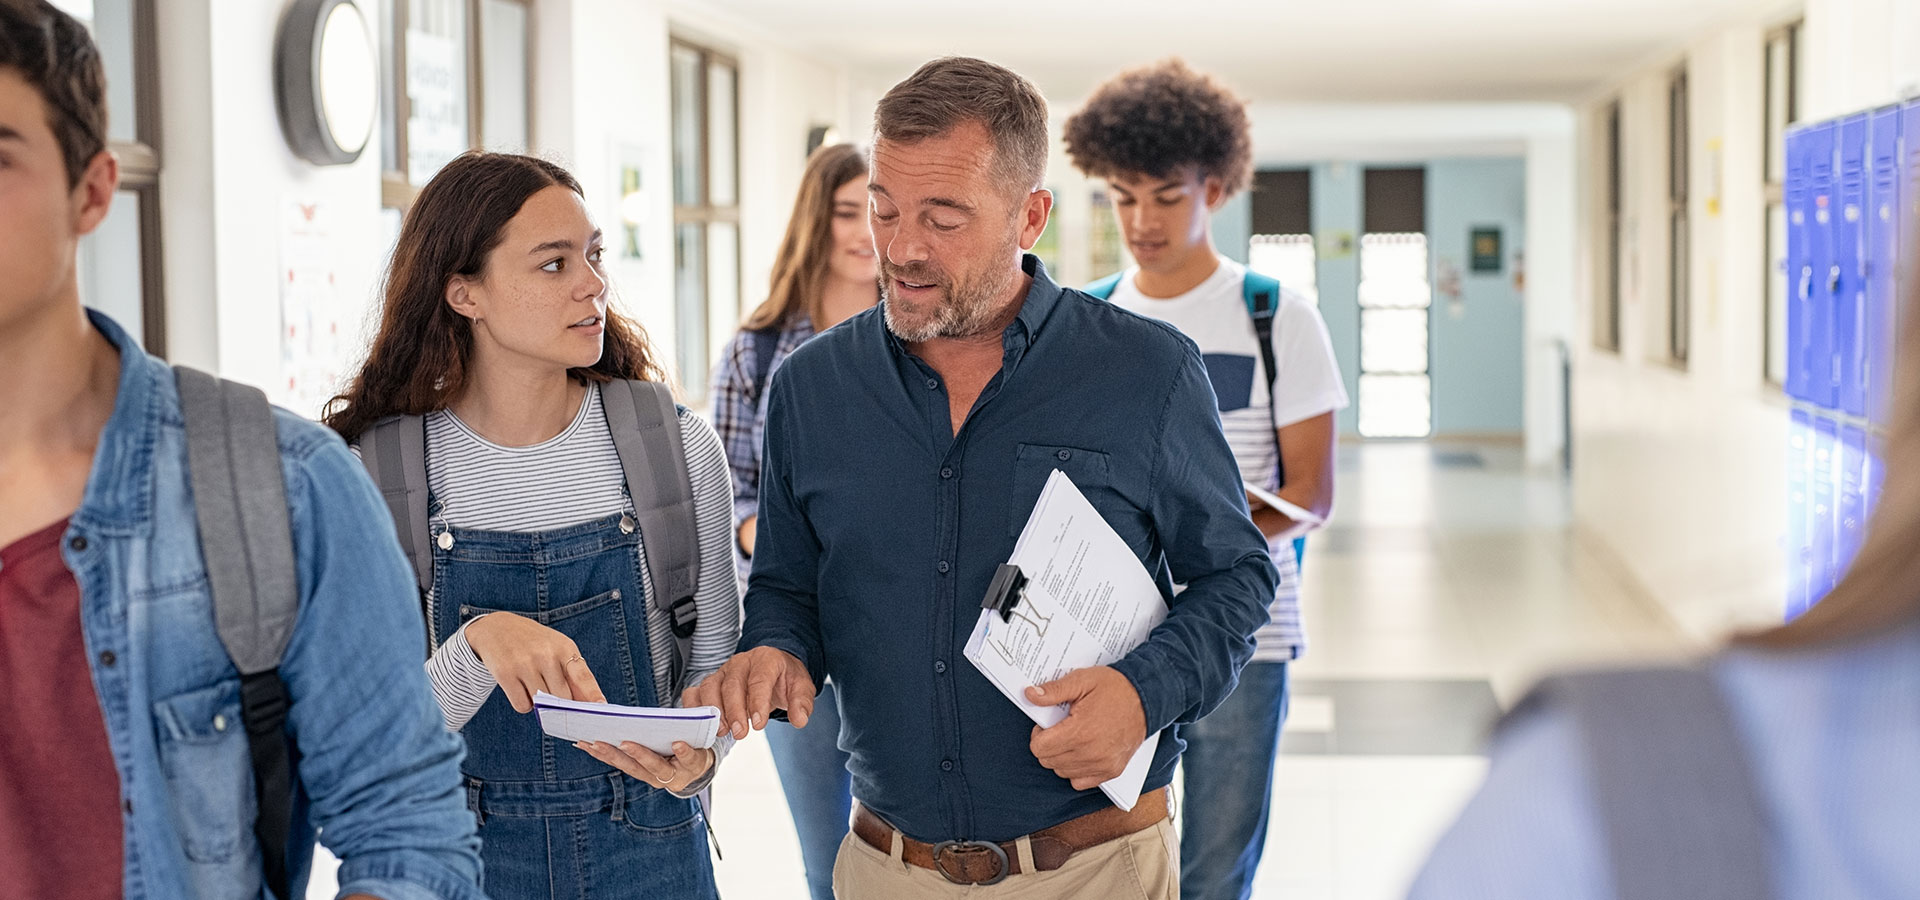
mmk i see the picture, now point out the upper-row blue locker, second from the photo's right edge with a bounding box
[1860,106,1901,424]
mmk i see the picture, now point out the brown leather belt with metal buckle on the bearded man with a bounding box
[852,787,1167,885]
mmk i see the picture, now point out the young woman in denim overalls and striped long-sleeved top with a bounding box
[326,154,739,900]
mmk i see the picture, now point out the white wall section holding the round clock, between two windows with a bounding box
[156,0,386,414]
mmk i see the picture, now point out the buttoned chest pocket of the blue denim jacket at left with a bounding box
[154,679,253,864]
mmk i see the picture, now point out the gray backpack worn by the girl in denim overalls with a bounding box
[359,382,706,686]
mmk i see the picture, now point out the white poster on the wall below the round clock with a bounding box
[273,200,348,418]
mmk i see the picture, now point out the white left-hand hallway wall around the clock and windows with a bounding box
[156,0,877,406]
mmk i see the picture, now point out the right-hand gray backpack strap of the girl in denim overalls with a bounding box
[599,382,699,704]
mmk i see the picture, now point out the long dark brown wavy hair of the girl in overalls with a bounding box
[323,152,666,441]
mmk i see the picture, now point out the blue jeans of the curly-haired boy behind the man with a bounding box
[1181,662,1286,900]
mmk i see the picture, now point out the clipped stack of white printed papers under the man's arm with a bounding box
[966,470,1167,810]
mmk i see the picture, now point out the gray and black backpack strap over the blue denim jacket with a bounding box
[175,367,300,900]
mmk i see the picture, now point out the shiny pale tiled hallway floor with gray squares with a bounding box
[315,443,1680,900]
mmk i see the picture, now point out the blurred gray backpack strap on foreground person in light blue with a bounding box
[1509,666,1774,900]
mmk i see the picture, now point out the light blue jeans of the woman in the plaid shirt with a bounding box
[766,681,852,900]
